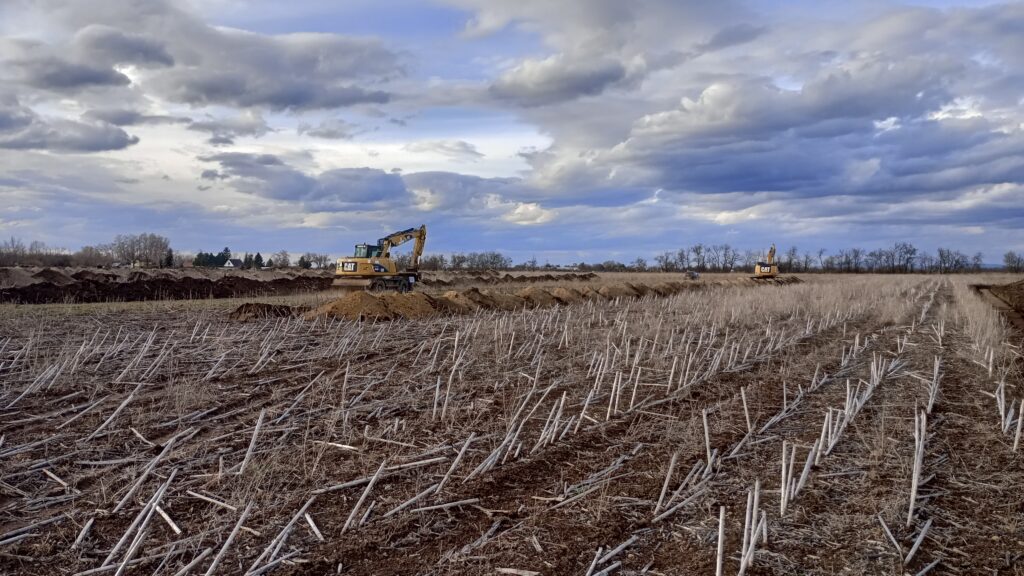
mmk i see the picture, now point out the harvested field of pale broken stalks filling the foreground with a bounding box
[0,276,1024,576]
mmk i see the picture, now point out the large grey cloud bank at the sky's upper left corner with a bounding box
[0,0,401,110]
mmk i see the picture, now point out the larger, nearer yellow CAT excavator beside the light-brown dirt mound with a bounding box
[332,225,427,292]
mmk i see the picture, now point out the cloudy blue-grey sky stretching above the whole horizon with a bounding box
[0,0,1024,262]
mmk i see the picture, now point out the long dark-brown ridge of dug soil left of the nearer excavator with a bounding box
[0,268,334,304]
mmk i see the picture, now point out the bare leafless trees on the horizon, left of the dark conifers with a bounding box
[0,234,174,266]
